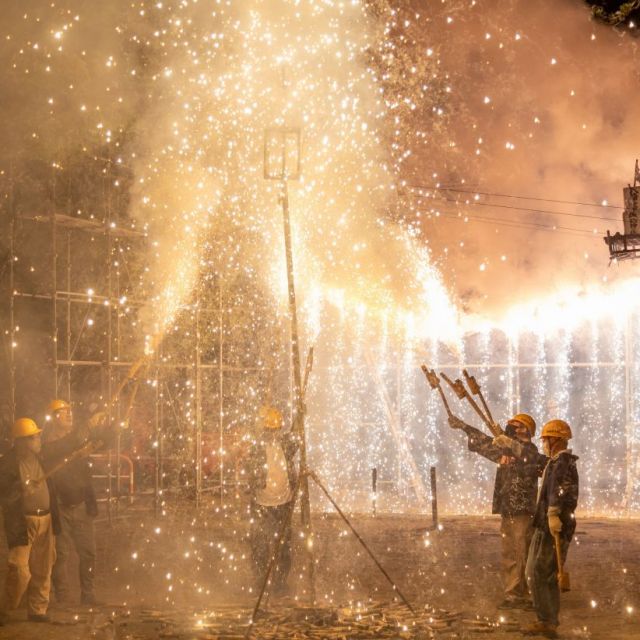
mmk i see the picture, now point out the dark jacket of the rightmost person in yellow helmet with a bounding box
[533,451,579,542]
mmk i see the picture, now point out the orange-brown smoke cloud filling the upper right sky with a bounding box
[407,0,640,318]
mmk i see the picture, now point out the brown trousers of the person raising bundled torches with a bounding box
[500,515,533,599]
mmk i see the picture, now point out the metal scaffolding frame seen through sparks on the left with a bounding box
[5,158,255,517]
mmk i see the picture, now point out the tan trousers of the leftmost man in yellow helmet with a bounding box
[4,514,56,615]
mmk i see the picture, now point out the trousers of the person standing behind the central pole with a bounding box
[250,502,291,590]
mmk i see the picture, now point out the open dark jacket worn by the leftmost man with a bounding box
[0,431,86,548]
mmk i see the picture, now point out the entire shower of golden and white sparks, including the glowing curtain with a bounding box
[4,0,640,528]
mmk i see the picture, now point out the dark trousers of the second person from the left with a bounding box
[52,502,96,602]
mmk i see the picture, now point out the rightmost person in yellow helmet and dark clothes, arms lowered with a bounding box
[525,420,579,638]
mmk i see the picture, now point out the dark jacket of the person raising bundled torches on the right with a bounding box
[464,425,541,516]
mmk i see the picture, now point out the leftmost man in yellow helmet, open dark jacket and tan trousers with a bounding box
[0,418,93,624]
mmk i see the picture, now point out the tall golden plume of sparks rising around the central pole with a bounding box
[127,2,456,335]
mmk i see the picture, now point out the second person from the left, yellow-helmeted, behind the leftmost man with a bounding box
[44,400,98,605]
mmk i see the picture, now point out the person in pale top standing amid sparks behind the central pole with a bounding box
[246,405,299,595]
